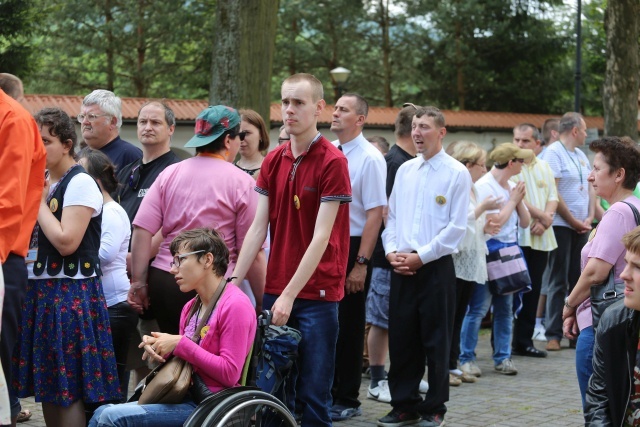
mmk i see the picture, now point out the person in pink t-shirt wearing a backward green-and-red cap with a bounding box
[128,105,266,334]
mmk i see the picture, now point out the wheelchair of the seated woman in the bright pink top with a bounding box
[184,311,297,427]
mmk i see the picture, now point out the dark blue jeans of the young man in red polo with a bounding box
[262,294,338,426]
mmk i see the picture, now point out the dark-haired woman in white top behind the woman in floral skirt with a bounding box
[78,148,138,401]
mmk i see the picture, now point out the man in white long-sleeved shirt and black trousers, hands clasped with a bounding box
[378,107,472,427]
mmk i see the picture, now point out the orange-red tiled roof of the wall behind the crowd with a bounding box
[23,95,636,131]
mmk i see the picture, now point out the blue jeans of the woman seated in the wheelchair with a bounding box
[89,400,196,427]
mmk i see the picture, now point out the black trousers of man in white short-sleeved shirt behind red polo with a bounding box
[332,236,372,408]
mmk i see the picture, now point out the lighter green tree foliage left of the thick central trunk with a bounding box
[29,0,214,98]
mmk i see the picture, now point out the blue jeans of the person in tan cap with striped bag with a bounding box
[460,283,513,365]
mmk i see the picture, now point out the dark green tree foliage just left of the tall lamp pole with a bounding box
[407,0,572,113]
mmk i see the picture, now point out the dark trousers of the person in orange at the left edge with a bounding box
[0,253,27,417]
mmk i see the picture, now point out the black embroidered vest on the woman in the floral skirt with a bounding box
[33,166,102,277]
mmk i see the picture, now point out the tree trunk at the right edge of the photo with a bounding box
[602,0,640,140]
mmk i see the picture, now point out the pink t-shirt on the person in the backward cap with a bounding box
[133,156,258,274]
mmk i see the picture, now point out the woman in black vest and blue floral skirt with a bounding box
[13,108,120,427]
